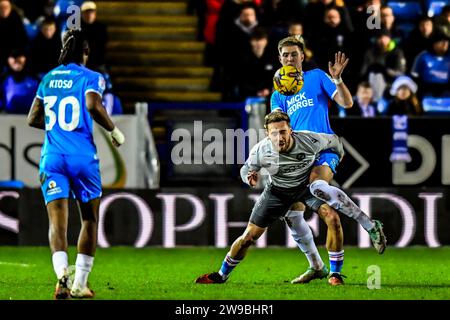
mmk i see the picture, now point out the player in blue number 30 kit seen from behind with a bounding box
[28,30,125,299]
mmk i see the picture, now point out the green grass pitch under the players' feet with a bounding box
[0,246,450,300]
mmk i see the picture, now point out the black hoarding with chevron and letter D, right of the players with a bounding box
[330,116,450,188]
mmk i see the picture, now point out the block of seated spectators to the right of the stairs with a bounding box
[197,0,450,117]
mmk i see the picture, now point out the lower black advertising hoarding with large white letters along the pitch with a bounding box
[0,187,450,248]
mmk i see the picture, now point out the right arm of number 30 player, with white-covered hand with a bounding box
[86,92,125,147]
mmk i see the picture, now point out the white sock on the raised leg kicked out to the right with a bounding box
[309,180,375,231]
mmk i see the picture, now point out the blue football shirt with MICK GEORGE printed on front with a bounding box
[270,69,337,134]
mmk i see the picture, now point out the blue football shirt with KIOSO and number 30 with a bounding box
[36,63,105,156]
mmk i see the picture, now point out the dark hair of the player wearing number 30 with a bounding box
[58,29,89,65]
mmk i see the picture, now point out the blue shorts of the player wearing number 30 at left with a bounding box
[39,154,102,205]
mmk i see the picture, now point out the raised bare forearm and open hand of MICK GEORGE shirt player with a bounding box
[328,51,353,109]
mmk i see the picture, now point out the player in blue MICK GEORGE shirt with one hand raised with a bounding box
[271,36,386,285]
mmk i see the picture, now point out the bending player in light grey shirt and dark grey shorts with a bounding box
[196,111,344,284]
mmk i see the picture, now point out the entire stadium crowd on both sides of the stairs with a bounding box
[0,0,450,117]
